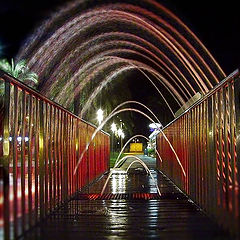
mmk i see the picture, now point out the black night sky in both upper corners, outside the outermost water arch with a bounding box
[0,0,240,74]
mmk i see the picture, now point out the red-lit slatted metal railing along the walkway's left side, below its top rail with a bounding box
[0,72,110,239]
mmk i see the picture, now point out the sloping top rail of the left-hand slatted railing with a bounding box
[0,70,110,136]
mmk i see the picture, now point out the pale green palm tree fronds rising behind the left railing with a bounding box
[0,59,38,94]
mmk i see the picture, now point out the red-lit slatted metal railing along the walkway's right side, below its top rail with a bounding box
[157,71,240,237]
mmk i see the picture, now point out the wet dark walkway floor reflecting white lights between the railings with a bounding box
[22,156,230,240]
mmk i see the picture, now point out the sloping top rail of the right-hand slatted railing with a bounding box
[160,69,240,130]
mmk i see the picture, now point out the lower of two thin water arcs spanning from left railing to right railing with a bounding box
[73,108,186,177]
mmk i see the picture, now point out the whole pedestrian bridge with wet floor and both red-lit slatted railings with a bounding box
[0,71,240,240]
